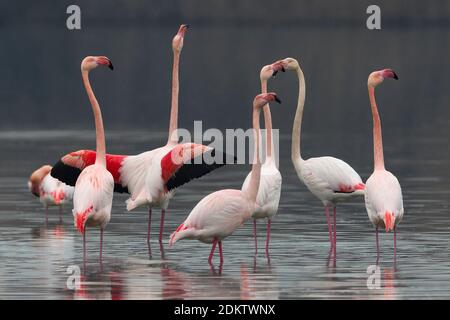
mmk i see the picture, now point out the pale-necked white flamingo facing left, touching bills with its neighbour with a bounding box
[274,58,365,252]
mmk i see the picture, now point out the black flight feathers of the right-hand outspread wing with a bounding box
[165,149,237,191]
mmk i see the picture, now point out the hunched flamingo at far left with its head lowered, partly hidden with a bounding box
[28,165,74,216]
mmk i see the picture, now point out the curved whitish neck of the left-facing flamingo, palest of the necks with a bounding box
[291,67,306,165]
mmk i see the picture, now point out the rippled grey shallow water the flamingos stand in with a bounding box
[0,131,450,299]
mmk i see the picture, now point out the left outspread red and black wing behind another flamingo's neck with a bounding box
[50,150,128,193]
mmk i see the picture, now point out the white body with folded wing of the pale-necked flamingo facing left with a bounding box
[302,157,364,193]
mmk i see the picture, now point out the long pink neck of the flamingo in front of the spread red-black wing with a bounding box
[81,70,106,166]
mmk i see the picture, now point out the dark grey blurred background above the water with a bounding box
[0,0,450,168]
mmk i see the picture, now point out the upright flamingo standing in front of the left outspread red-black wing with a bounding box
[73,56,114,262]
